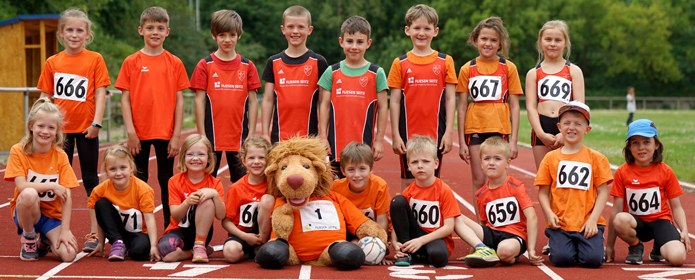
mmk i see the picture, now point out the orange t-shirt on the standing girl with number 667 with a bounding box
[456,58,524,134]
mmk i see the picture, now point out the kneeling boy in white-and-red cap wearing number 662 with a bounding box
[534,101,613,268]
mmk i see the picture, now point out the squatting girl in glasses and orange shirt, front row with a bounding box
[159,134,225,263]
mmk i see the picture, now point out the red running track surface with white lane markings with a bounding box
[0,123,695,279]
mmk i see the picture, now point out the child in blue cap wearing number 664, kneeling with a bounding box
[606,119,690,266]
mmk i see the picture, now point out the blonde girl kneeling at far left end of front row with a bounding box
[5,98,79,262]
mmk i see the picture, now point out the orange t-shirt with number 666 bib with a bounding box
[36,49,111,133]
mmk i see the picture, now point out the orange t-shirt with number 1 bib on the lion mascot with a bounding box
[271,192,369,262]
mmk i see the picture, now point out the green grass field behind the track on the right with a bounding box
[519,110,695,182]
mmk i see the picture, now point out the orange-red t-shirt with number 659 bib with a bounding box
[475,176,533,240]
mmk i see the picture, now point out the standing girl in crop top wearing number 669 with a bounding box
[526,20,584,169]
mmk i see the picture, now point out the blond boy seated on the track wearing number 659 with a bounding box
[454,137,543,267]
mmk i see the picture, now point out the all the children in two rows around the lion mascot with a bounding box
[5,1,690,267]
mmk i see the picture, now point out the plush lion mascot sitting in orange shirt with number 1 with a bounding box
[255,137,387,270]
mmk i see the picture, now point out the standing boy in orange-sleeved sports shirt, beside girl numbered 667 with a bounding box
[388,4,458,191]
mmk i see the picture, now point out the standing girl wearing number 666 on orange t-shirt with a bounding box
[36,9,111,252]
